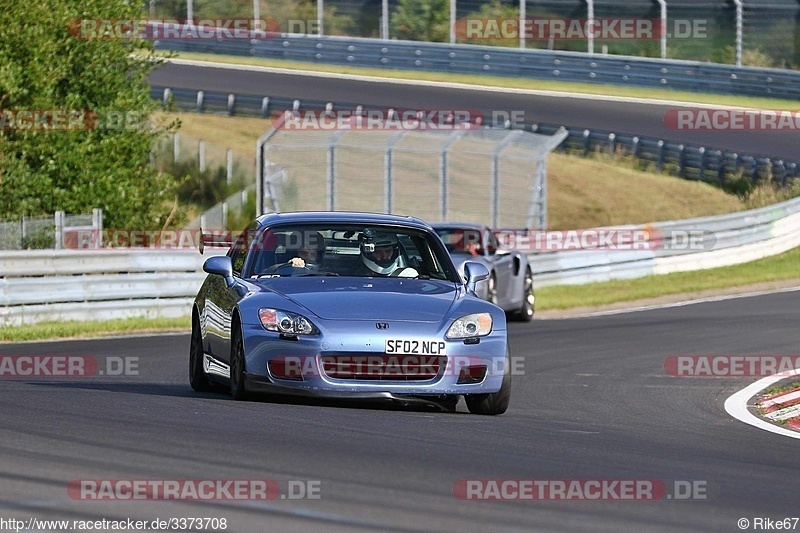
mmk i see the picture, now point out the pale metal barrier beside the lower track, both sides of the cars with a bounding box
[0,198,800,325]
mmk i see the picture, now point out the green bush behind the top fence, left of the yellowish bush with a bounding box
[390,0,450,43]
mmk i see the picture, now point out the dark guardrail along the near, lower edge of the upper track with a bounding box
[150,84,800,186]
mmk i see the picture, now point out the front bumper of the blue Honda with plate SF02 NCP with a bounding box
[243,321,510,400]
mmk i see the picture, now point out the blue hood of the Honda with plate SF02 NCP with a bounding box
[253,277,458,322]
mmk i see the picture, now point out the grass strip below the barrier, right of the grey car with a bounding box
[536,244,800,311]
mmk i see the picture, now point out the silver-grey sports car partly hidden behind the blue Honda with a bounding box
[433,222,536,322]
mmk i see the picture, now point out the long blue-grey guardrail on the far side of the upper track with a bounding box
[156,34,800,99]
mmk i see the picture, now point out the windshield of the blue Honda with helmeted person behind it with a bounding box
[245,224,459,281]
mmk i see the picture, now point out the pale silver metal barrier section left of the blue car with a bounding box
[0,249,225,326]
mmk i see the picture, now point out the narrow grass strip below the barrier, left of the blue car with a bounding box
[0,317,191,342]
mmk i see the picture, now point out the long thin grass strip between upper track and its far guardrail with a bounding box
[167,52,797,110]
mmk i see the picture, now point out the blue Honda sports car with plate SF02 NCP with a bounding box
[189,212,511,415]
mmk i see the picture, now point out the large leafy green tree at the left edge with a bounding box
[0,0,177,229]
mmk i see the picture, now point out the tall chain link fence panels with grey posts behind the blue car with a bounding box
[257,124,567,229]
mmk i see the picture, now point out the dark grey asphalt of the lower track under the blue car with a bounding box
[0,291,800,531]
